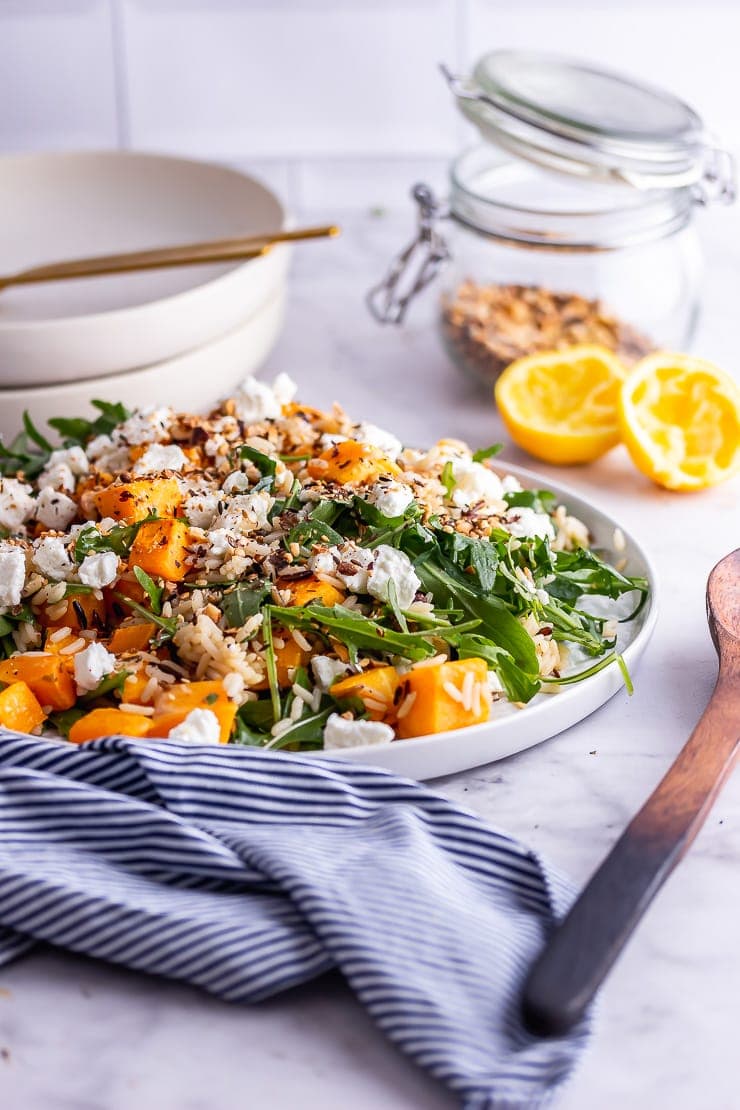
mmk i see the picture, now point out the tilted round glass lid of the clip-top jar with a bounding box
[443,50,736,203]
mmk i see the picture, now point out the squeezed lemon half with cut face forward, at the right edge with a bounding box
[619,351,740,490]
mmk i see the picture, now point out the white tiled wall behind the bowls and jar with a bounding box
[0,0,740,209]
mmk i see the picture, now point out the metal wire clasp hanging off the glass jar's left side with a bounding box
[366,183,450,324]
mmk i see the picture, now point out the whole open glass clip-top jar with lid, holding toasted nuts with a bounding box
[368,51,734,383]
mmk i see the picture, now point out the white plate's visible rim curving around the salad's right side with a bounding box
[316,466,658,779]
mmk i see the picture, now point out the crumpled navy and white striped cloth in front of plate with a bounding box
[0,730,587,1110]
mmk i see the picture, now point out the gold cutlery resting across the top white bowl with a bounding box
[0,223,339,291]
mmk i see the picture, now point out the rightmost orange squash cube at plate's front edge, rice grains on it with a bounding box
[396,659,490,739]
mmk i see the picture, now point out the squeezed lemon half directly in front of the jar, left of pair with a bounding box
[495,345,626,464]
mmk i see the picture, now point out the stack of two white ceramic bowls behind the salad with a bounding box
[0,151,290,442]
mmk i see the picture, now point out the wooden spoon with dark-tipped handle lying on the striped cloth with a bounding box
[524,548,740,1036]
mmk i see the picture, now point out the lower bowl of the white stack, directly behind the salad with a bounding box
[0,289,285,443]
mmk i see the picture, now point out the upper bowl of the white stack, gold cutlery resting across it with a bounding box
[0,151,288,387]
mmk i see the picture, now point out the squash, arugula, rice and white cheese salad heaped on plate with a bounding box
[0,375,648,750]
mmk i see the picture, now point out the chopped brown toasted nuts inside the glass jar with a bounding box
[442,280,655,383]
